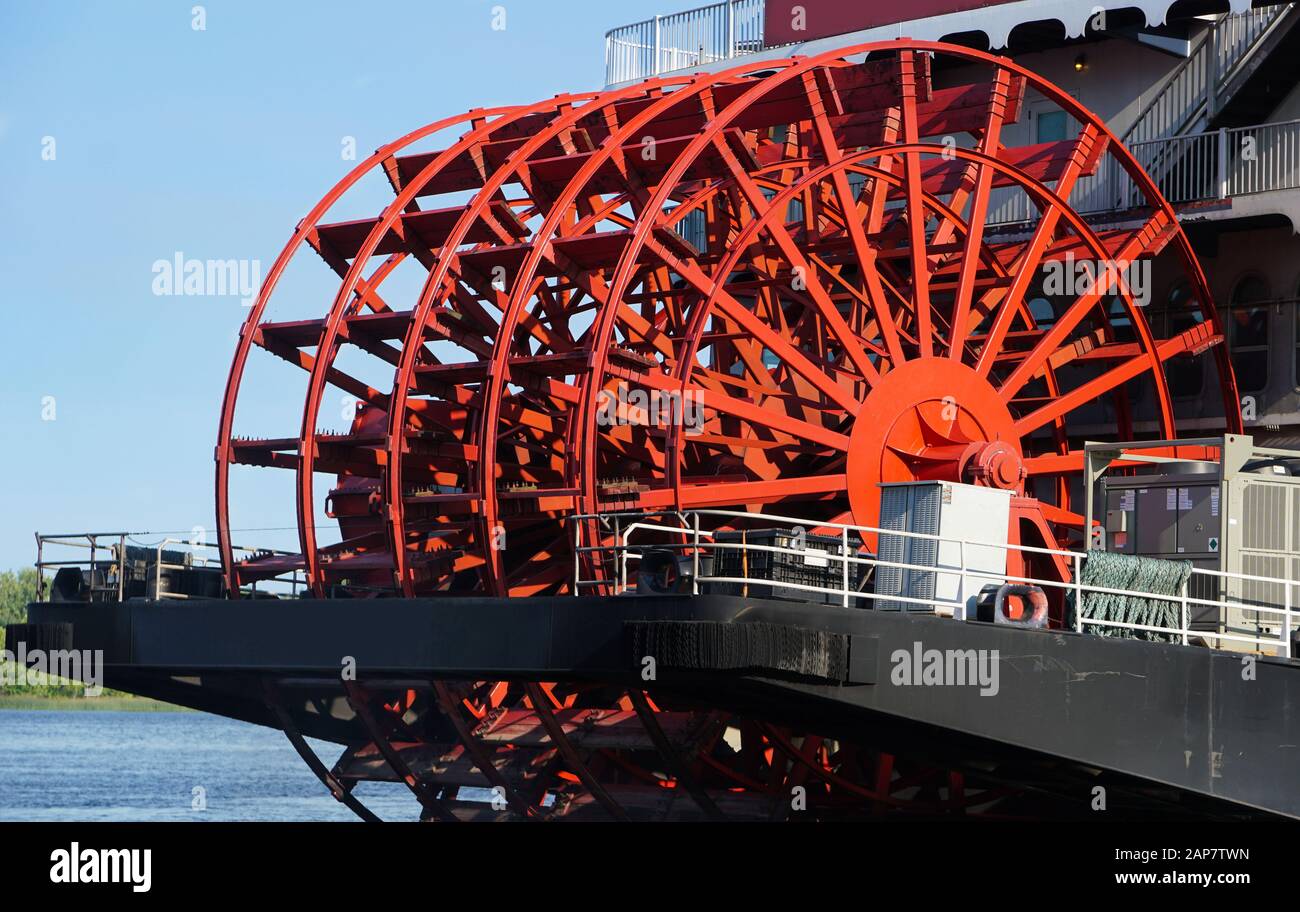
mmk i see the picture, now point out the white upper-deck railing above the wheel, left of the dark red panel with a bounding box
[605,0,764,86]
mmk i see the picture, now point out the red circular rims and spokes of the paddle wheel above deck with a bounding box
[217,42,1236,595]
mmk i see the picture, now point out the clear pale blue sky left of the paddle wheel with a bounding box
[0,0,670,569]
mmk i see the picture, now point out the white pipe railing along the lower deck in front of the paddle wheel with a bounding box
[569,509,1297,659]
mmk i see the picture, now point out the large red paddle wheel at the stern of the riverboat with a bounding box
[216,40,1240,813]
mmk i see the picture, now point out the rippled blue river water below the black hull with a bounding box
[0,709,419,821]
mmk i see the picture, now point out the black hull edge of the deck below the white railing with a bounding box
[29,595,1300,817]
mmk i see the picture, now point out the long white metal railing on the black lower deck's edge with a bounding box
[569,509,1300,659]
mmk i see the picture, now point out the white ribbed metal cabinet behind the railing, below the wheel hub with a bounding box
[875,481,1011,618]
